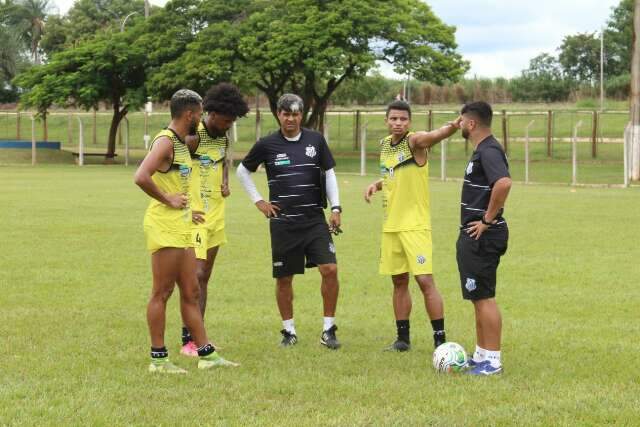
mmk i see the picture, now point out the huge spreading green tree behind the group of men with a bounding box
[152,0,468,128]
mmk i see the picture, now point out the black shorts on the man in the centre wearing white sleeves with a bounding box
[270,218,336,278]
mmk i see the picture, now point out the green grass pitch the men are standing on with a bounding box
[0,166,640,426]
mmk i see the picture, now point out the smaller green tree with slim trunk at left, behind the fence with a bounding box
[15,29,147,158]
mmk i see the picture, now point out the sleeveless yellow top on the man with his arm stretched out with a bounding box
[380,132,431,232]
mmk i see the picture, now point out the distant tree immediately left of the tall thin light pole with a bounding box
[558,33,600,85]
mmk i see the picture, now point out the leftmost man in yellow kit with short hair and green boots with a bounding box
[134,89,236,374]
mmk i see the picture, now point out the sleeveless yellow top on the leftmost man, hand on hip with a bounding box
[144,129,192,235]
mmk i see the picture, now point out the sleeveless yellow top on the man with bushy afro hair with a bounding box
[191,122,229,230]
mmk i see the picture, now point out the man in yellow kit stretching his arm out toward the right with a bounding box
[364,101,460,351]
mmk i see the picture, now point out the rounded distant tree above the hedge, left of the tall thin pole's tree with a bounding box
[510,53,571,102]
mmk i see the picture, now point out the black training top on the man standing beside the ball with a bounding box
[460,135,509,229]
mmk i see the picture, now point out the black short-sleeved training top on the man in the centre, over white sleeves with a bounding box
[242,129,336,222]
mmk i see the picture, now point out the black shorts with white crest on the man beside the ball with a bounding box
[456,229,509,300]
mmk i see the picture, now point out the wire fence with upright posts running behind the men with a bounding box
[0,110,629,185]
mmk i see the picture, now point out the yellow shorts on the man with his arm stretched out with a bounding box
[380,230,433,276]
